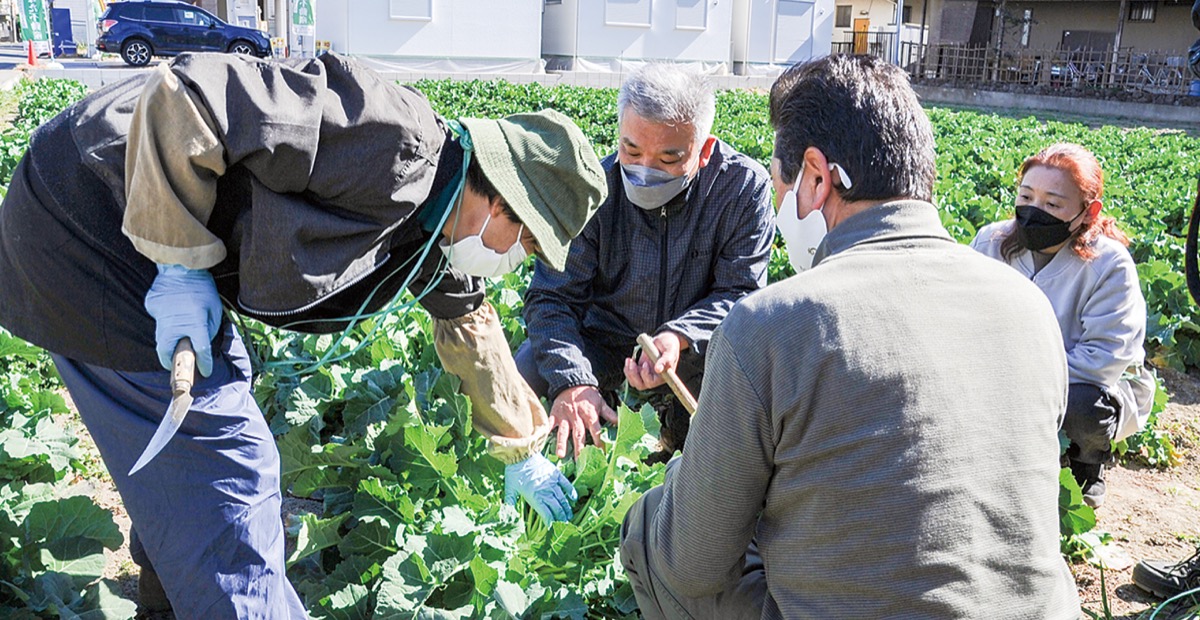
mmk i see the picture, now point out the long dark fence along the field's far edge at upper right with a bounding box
[900,43,1192,95]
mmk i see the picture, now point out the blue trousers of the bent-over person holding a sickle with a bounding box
[54,323,308,620]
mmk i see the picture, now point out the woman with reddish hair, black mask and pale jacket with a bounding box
[971,143,1156,507]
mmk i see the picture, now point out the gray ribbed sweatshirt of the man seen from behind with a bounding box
[635,201,1080,620]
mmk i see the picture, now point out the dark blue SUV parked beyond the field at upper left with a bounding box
[96,1,271,67]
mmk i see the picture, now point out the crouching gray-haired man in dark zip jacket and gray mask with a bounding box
[516,64,775,458]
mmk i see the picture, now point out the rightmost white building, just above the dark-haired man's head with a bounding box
[732,0,834,76]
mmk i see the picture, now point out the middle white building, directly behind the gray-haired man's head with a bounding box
[541,0,734,73]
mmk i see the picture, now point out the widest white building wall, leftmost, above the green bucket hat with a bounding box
[317,0,542,60]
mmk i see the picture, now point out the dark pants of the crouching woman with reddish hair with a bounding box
[1062,384,1121,465]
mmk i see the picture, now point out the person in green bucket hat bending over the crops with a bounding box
[0,54,606,619]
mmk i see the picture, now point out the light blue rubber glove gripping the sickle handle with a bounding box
[145,265,221,377]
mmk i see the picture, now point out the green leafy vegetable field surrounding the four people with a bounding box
[0,74,1200,620]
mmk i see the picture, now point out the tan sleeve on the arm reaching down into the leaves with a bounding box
[433,303,551,464]
